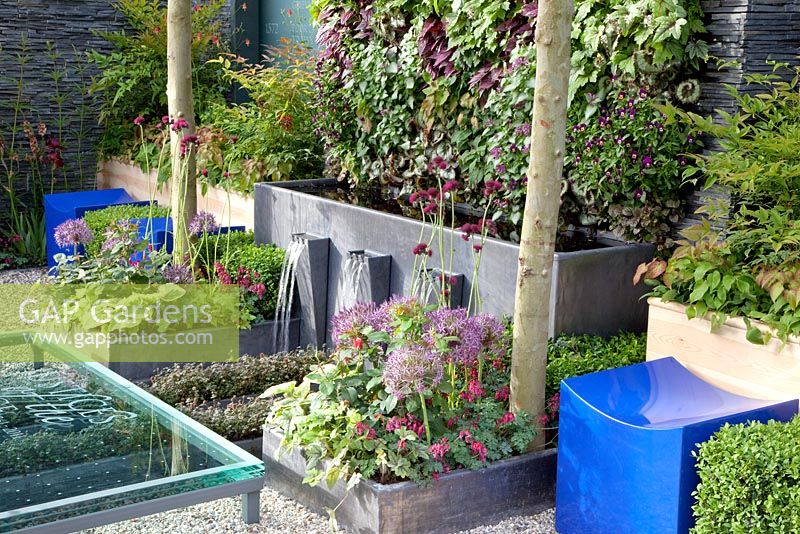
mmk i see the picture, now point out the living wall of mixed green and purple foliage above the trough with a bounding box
[312,0,707,240]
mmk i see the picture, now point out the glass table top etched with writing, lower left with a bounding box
[0,342,264,532]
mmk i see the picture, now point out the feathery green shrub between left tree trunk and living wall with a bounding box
[198,44,323,193]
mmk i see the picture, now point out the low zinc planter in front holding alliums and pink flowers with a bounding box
[263,429,556,534]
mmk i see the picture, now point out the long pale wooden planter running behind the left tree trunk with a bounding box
[97,159,255,230]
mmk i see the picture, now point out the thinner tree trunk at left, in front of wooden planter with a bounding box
[167,0,197,262]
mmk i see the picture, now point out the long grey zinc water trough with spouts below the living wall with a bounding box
[255,180,654,336]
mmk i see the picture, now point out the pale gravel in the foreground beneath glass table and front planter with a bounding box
[83,488,555,534]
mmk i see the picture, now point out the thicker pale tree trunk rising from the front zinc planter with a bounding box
[511,0,574,444]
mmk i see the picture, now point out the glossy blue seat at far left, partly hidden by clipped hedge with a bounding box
[44,189,148,267]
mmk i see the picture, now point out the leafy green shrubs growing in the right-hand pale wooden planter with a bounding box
[643,65,800,343]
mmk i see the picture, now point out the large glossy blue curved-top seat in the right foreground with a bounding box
[556,358,798,534]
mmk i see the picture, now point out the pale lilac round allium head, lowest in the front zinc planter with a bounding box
[383,345,444,399]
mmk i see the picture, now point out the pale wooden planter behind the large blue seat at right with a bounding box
[647,298,800,400]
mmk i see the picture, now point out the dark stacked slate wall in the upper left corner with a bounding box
[0,0,231,221]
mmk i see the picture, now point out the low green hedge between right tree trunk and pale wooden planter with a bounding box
[545,333,647,424]
